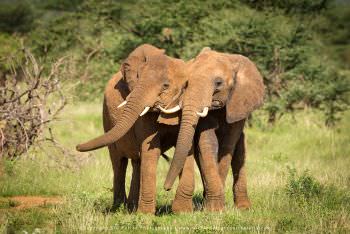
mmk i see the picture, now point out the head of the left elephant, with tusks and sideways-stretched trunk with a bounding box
[77,45,186,151]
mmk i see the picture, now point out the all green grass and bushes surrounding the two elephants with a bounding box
[0,0,350,233]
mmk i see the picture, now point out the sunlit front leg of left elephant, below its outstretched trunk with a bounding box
[138,135,160,214]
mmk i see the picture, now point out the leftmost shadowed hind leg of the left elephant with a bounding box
[108,145,128,210]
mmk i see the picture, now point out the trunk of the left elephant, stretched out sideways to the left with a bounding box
[76,85,146,152]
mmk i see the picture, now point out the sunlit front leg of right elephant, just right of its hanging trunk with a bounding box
[198,129,225,211]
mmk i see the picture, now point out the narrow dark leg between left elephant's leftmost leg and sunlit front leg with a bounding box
[127,159,141,212]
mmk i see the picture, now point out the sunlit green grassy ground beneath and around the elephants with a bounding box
[0,104,350,233]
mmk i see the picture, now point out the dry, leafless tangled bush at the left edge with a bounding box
[0,49,66,159]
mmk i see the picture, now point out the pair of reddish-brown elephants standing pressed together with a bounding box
[77,44,265,213]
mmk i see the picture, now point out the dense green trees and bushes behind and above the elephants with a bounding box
[0,0,350,125]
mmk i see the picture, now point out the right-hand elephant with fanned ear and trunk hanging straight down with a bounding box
[164,48,265,210]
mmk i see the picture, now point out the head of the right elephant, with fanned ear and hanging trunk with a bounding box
[164,48,265,190]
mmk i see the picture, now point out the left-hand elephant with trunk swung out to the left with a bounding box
[77,44,194,213]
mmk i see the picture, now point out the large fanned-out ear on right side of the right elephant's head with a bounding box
[226,55,265,123]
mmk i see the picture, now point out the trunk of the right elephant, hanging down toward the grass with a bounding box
[164,85,214,191]
